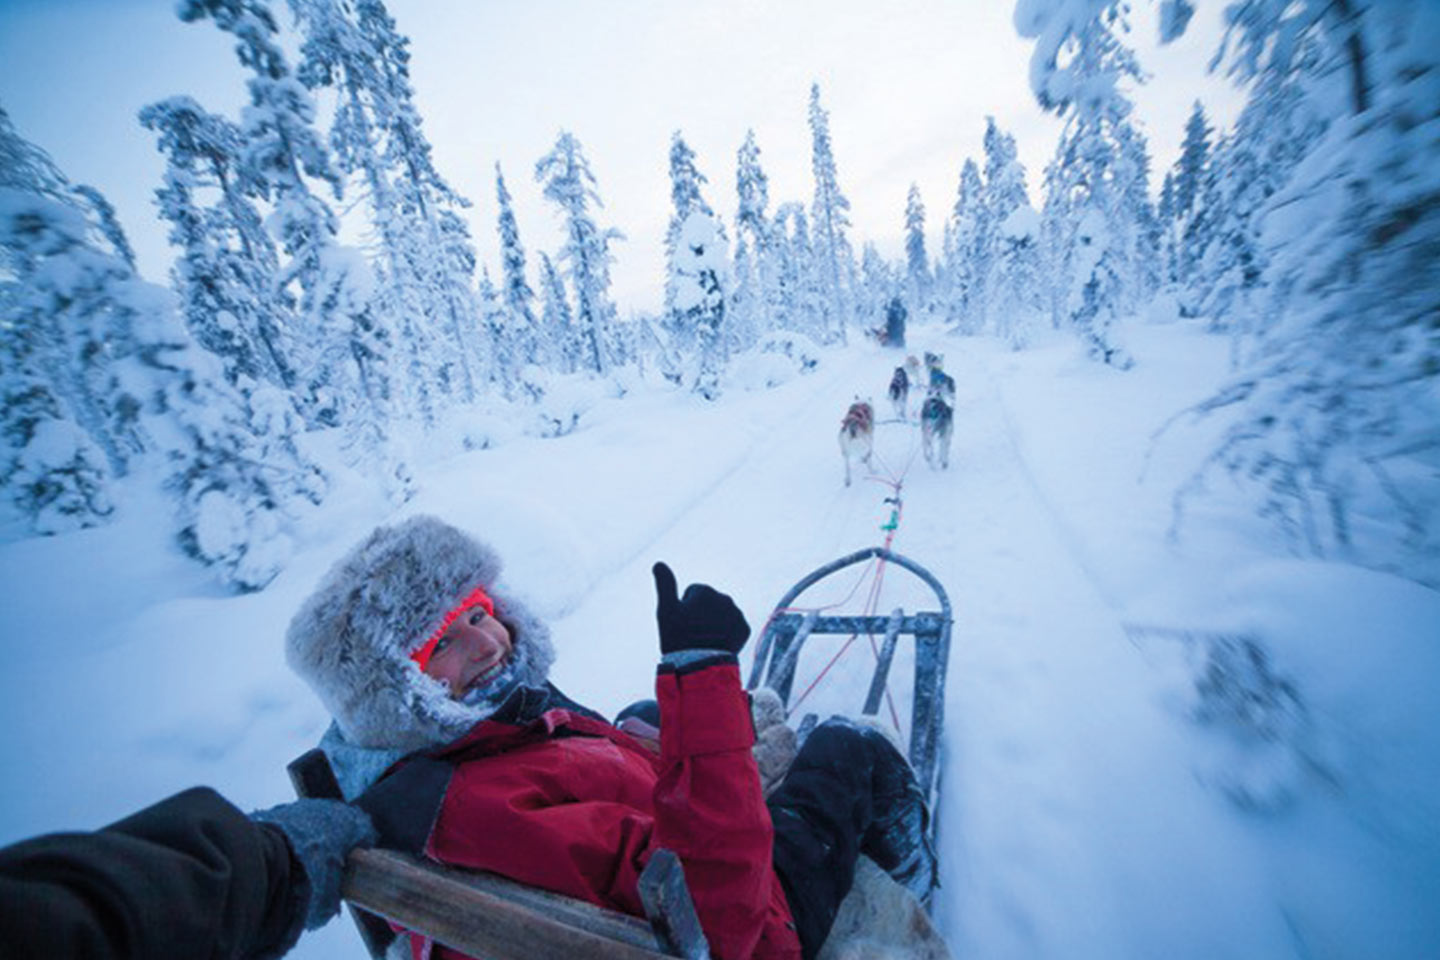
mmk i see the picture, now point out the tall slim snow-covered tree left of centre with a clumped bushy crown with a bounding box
[536,131,624,376]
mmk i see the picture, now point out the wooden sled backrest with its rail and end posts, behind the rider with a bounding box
[287,747,710,960]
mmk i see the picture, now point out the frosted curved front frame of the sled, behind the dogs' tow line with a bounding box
[746,547,953,810]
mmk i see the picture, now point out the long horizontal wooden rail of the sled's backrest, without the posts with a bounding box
[340,849,675,960]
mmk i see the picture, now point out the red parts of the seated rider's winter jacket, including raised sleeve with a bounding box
[415,662,801,960]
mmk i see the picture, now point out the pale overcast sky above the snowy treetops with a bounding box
[0,0,1238,309]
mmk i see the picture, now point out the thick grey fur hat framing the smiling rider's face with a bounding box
[285,515,554,751]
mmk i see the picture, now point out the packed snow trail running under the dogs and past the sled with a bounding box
[556,333,1292,957]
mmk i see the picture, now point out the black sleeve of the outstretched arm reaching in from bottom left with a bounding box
[0,787,310,960]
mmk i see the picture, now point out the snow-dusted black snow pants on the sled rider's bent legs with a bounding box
[768,717,935,960]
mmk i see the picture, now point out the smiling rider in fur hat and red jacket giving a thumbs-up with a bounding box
[287,517,935,960]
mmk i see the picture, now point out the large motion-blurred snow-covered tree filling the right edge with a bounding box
[1169,0,1440,583]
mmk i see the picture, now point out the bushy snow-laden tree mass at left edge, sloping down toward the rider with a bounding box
[0,110,325,589]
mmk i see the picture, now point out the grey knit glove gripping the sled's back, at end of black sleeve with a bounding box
[251,799,376,930]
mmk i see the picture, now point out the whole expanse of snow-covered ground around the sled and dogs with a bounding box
[0,316,1440,959]
